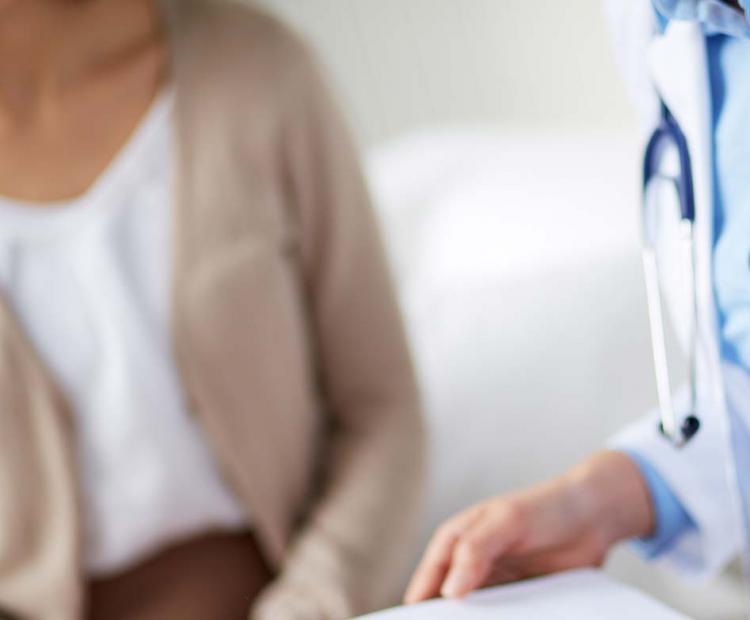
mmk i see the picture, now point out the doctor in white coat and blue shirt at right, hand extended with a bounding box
[406,0,750,603]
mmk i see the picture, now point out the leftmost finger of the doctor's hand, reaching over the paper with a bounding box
[404,505,484,605]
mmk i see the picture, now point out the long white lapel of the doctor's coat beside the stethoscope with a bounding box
[649,22,724,411]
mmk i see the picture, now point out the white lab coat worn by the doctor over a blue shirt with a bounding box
[606,0,750,575]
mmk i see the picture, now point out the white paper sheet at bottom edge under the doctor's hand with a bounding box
[365,570,686,620]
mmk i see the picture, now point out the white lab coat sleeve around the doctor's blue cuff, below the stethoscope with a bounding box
[609,402,742,578]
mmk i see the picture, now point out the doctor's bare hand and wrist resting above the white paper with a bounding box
[404,451,654,604]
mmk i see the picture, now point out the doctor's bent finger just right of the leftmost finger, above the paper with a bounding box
[441,498,528,597]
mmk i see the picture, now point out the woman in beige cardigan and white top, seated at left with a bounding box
[0,0,421,620]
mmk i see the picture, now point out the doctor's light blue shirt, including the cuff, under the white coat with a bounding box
[627,0,750,558]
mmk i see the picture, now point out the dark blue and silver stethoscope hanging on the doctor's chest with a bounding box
[643,101,700,447]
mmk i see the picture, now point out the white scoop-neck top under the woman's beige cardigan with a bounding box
[0,93,248,575]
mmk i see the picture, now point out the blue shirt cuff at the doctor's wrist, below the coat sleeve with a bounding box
[623,450,695,560]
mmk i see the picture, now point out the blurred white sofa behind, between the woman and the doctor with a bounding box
[368,128,743,620]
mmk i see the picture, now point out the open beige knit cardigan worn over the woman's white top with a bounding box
[0,0,423,620]
